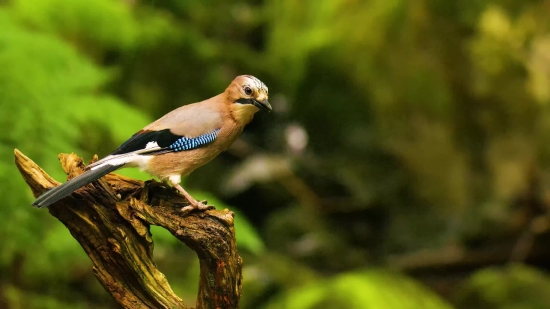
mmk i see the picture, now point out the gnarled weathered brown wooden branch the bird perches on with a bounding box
[15,149,242,309]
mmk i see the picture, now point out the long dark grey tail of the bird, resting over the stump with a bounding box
[32,164,124,208]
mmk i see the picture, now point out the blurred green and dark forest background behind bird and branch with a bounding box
[0,0,550,309]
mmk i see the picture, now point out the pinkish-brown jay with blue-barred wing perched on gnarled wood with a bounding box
[32,75,272,212]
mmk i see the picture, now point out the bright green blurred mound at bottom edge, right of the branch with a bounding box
[266,270,452,309]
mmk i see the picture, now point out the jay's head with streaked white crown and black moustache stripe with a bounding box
[226,75,271,121]
